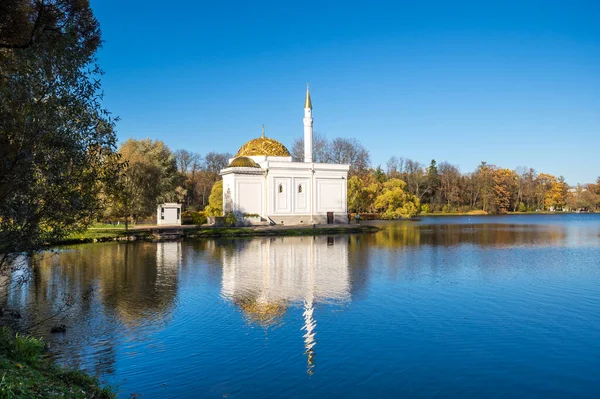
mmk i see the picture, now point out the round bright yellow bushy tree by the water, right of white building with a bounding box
[375,179,420,219]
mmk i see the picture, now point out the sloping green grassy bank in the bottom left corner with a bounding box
[0,327,116,399]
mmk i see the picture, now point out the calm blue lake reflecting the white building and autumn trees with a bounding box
[2,215,600,398]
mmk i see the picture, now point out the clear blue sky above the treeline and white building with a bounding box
[91,0,600,184]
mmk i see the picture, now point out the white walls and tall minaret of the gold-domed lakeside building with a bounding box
[221,90,350,224]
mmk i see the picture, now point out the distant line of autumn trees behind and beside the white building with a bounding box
[105,137,600,225]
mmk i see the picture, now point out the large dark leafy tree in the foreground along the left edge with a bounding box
[0,0,119,253]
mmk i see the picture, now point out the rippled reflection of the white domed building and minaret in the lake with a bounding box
[222,237,350,374]
